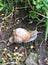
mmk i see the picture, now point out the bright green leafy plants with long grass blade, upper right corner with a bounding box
[28,0,48,41]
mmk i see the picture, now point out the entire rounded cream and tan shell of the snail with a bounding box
[13,28,30,43]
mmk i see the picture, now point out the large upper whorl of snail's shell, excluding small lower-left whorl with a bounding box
[13,28,30,41]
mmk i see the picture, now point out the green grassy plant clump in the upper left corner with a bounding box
[0,0,20,16]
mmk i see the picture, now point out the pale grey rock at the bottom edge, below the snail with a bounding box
[25,53,38,65]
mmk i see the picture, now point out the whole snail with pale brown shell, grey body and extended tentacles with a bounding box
[9,28,42,43]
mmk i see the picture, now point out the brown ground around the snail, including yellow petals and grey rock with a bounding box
[0,4,48,65]
